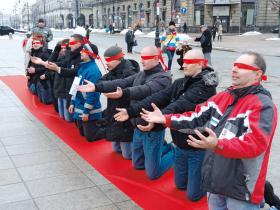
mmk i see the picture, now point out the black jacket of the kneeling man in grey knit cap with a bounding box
[97,60,139,142]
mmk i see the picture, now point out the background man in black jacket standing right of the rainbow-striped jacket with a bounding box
[194,25,212,66]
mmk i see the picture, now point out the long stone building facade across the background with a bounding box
[29,0,279,32]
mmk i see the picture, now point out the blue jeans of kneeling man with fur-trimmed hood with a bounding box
[174,147,206,201]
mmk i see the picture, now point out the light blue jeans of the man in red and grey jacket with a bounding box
[208,193,260,210]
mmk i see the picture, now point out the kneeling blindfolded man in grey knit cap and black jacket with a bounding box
[88,45,140,159]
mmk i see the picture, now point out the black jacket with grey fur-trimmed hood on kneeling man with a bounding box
[127,67,218,149]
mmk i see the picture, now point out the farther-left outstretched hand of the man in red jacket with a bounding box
[140,103,166,124]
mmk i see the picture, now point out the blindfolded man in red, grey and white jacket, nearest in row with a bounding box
[142,52,277,210]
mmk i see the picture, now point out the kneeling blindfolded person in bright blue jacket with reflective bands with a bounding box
[69,44,102,141]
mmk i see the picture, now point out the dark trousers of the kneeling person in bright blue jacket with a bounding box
[76,120,105,141]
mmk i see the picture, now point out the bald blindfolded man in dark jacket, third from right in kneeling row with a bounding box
[78,46,173,179]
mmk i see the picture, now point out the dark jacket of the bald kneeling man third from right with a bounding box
[96,64,171,130]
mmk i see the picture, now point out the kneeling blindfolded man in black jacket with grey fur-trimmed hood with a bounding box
[115,50,218,201]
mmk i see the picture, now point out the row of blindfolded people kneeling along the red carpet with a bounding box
[21,18,277,210]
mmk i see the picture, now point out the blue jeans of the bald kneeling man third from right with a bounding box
[132,128,174,179]
